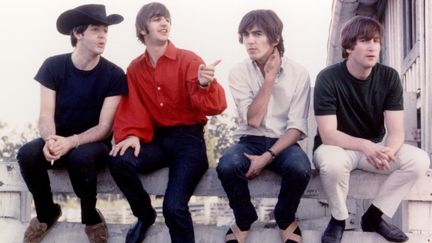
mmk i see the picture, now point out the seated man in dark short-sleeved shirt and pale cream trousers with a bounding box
[313,16,430,243]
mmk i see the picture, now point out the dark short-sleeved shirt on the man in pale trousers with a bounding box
[314,61,403,150]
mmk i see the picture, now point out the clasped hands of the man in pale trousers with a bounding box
[362,141,394,170]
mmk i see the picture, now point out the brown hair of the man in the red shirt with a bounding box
[135,2,171,44]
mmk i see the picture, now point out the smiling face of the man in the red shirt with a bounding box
[141,16,171,45]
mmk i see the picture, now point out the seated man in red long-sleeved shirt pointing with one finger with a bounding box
[109,3,227,243]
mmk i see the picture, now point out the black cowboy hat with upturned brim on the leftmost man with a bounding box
[57,4,123,35]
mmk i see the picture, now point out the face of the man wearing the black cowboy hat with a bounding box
[75,24,108,55]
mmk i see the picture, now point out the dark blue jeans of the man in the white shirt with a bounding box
[217,136,311,229]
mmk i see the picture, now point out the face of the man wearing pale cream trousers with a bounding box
[346,35,381,69]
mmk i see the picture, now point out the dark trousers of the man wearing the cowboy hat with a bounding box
[17,138,109,225]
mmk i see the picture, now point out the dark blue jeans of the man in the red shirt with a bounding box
[109,125,208,243]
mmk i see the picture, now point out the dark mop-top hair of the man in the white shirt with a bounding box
[238,9,285,56]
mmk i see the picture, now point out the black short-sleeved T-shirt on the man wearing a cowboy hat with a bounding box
[35,53,127,144]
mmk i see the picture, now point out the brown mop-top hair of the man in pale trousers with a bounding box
[341,16,384,58]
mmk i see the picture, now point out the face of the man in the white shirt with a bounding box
[242,26,276,63]
